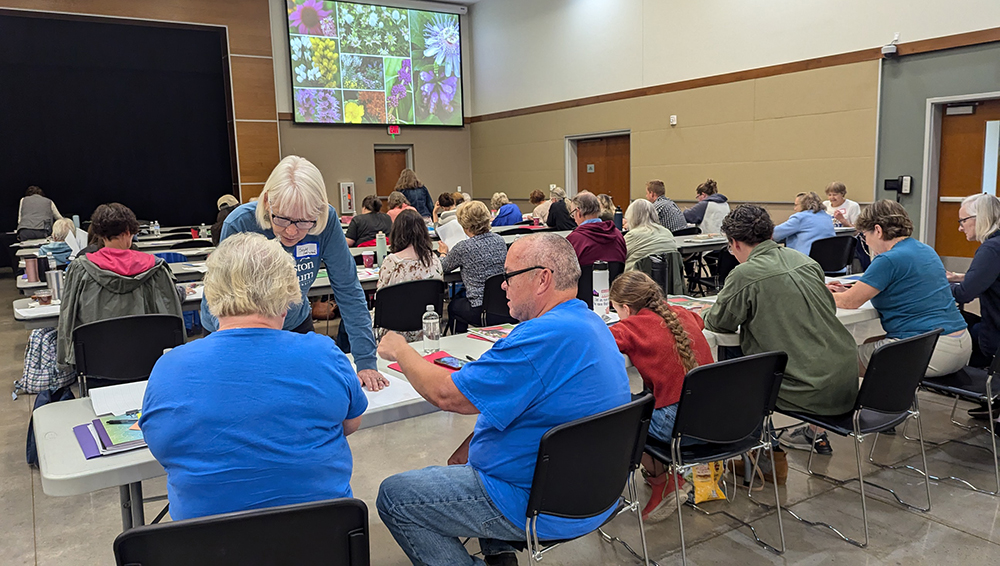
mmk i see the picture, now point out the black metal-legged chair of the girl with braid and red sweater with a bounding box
[645,352,788,564]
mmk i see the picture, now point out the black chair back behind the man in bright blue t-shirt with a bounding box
[527,393,655,519]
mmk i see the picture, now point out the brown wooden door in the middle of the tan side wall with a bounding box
[576,135,630,211]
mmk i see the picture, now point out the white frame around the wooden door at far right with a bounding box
[920,91,1000,247]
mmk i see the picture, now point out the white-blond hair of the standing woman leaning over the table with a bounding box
[257,155,330,235]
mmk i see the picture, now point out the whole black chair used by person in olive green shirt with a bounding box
[778,329,941,548]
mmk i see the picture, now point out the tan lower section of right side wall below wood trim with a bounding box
[471,62,878,207]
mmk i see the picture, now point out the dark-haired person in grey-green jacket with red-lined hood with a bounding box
[56,202,183,366]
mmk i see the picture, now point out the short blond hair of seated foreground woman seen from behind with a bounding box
[205,232,302,318]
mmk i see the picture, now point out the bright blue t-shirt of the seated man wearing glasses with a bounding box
[452,299,631,540]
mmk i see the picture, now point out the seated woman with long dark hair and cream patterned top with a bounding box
[375,209,447,342]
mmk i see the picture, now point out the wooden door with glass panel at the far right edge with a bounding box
[934,100,1000,257]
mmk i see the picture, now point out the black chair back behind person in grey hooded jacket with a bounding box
[73,314,184,381]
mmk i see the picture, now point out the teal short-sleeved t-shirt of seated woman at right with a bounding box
[861,238,966,339]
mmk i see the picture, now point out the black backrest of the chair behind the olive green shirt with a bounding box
[854,328,941,414]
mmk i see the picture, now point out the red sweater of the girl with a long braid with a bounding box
[611,306,713,409]
